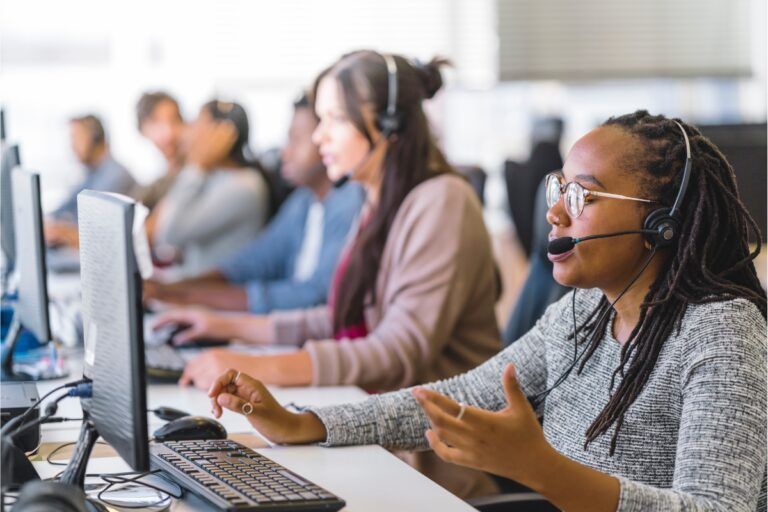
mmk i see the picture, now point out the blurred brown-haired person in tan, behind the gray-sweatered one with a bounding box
[131,91,185,210]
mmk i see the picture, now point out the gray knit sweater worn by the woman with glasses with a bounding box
[310,290,766,512]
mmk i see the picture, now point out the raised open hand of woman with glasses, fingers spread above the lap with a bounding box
[413,364,552,487]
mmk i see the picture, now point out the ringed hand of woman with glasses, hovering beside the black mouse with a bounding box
[208,370,327,444]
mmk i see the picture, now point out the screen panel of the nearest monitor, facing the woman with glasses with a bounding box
[77,190,149,471]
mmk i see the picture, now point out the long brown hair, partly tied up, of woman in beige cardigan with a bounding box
[313,50,453,330]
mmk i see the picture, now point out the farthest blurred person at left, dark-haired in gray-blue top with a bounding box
[45,114,136,247]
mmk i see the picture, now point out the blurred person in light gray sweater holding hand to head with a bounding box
[148,100,271,277]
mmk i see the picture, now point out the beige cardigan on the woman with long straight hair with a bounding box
[270,175,500,390]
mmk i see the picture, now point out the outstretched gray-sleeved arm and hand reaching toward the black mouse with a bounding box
[202,302,552,449]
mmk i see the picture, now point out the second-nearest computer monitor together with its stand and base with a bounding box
[2,167,63,380]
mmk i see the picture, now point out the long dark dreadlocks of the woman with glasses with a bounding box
[579,110,766,455]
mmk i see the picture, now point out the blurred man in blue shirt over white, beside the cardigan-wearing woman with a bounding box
[144,97,364,313]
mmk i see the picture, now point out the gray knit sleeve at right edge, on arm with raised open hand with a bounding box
[608,299,766,512]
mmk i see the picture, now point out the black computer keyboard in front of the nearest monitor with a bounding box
[150,439,345,511]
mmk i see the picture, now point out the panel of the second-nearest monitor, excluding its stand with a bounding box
[11,167,51,343]
